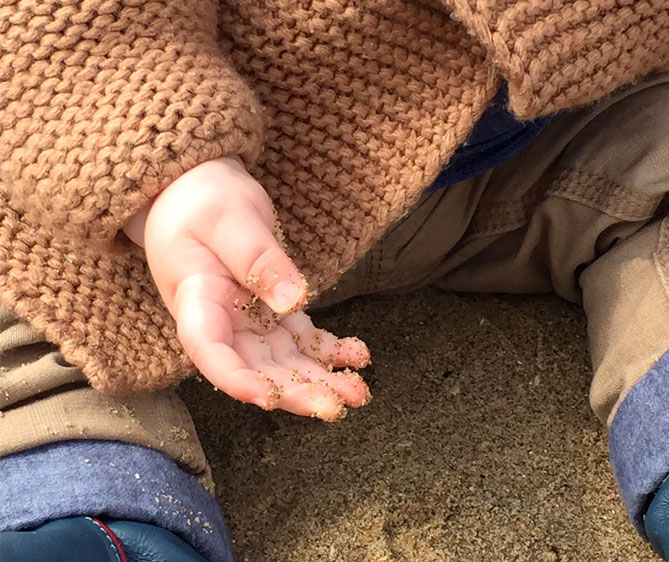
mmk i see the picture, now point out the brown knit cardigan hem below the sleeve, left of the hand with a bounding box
[0,191,194,394]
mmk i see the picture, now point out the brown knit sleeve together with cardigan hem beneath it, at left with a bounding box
[0,0,262,393]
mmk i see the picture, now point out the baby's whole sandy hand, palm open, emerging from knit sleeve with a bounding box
[124,158,370,421]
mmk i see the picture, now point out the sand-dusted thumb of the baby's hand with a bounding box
[194,201,307,314]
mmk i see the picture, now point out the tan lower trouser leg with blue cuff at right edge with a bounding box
[581,217,669,535]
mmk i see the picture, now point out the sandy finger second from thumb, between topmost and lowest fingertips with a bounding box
[265,327,371,408]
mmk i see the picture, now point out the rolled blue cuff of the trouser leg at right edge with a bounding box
[609,351,669,539]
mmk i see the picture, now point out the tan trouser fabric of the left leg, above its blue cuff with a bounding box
[0,302,211,476]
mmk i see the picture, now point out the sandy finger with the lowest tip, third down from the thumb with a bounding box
[234,332,346,421]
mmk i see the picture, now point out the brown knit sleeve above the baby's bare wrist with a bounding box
[0,0,262,240]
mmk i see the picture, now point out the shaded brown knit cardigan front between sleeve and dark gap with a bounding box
[219,0,499,292]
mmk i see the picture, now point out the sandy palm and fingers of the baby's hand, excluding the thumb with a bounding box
[176,255,371,421]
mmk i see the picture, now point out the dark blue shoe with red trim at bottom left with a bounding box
[0,517,207,562]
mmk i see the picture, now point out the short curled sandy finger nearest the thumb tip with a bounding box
[280,311,371,369]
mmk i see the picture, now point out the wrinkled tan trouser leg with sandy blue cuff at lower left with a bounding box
[0,308,232,561]
